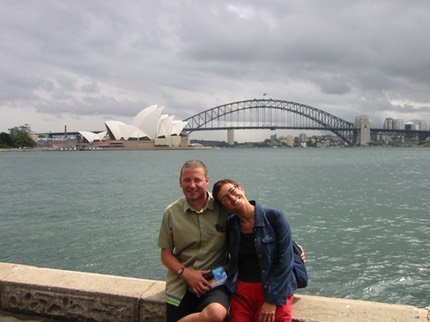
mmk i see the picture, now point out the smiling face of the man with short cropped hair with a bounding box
[179,168,209,203]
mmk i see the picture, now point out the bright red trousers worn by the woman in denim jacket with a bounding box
[230,281,294,322]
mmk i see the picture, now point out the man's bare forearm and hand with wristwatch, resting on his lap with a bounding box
[161,248,212,295]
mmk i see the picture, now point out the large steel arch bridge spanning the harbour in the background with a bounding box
[184,99,430,145]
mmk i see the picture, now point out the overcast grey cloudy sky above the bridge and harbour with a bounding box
[0,0,430,140]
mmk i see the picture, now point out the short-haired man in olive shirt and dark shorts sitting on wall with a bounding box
[158,160,230,322]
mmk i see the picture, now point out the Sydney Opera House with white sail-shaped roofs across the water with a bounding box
[79,105,190,149]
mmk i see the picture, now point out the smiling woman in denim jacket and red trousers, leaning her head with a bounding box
[212,179,297,322]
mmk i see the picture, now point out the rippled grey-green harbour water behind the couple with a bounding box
[0,148,430,307]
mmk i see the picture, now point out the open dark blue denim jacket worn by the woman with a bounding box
[226,201,297,305]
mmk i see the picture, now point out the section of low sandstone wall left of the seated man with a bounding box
[0,263,165,322]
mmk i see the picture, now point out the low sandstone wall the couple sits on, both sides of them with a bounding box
[0,263,429,322]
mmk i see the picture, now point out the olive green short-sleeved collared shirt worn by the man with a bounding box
[158,192,228,306]
